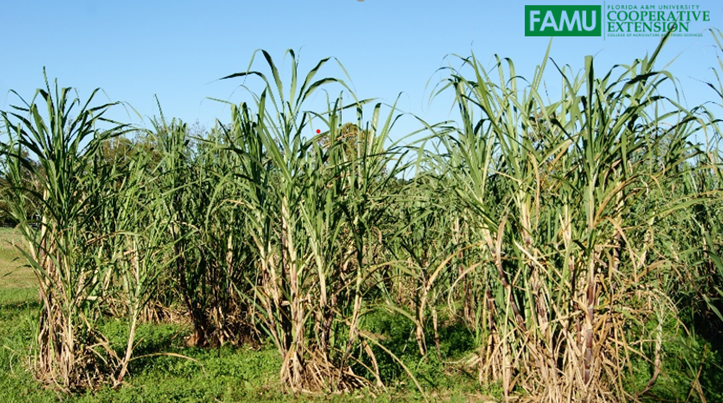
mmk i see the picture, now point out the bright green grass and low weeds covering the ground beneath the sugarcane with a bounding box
[0,229,721,403]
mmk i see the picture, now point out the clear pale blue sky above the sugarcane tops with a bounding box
[0,0,723,144]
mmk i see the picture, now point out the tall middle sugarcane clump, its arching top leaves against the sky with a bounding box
[219,51,412,390]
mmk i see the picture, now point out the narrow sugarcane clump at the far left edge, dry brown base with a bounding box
[2,77,128,391]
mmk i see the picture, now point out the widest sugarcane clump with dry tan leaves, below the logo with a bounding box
[442,33,698,401]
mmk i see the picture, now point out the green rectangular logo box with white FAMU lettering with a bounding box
[525,6,602,36]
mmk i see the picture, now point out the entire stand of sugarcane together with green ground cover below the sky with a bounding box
[0,33,723,403]
